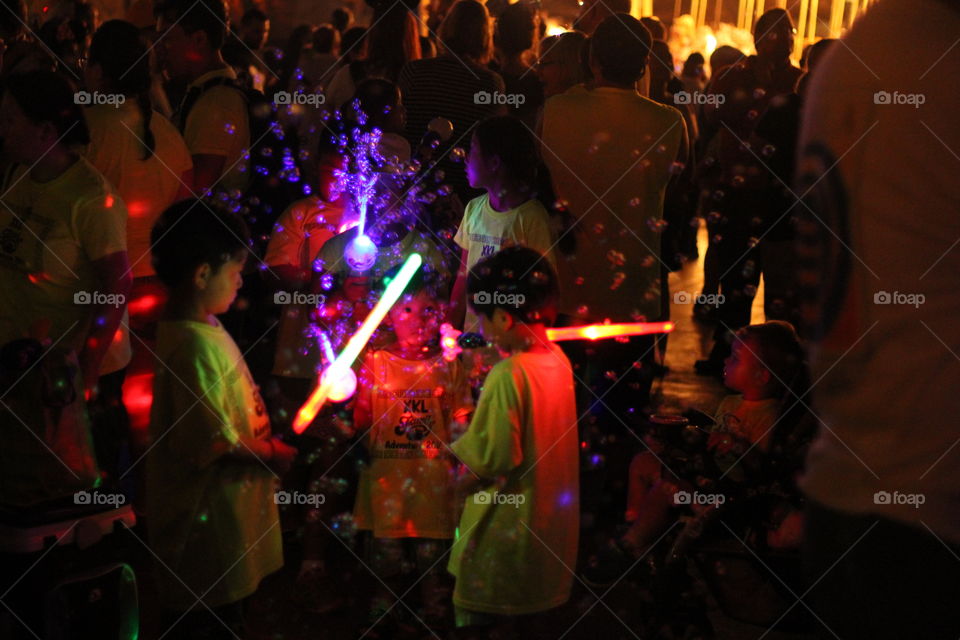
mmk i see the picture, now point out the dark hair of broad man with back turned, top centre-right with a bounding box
[590,13,653,85]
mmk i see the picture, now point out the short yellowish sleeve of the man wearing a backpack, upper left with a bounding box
[183,87,250,158]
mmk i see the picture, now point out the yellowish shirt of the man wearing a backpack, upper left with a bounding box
[183,67,256,191]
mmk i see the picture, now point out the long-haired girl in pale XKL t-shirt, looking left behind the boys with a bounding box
[450,116,554,332]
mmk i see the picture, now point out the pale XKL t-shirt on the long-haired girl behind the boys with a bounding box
[454,193,556,332]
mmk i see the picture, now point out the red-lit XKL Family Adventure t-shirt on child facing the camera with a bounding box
[354,351,473,538]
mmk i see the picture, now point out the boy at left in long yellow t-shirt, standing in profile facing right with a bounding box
[147,200,296,638]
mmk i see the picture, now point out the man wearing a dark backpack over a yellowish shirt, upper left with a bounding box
[154,0,251,195]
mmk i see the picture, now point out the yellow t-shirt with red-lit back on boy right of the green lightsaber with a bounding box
[448,345,580,615]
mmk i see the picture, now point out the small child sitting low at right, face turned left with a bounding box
[585,320,810,585]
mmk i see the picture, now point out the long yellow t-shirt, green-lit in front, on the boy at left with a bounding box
[147,321,283,610]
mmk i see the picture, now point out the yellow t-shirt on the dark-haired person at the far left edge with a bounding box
[0,158,129,361]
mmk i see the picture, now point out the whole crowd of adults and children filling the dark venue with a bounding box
[0,0,960,638]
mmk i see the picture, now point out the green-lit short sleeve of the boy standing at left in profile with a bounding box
[158,345,237,468]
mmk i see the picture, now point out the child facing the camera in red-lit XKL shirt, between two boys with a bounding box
[353,269,473,628]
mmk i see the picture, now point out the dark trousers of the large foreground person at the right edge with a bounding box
[797,504,960,640]
